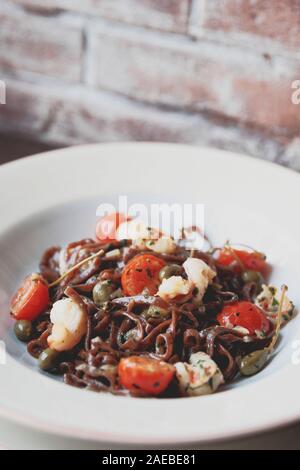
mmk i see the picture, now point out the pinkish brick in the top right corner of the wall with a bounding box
[194,0,300,51]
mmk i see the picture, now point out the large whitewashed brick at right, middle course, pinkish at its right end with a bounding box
[88,27,300,135]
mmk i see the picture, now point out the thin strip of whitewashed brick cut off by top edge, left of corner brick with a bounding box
[14,0,192,33]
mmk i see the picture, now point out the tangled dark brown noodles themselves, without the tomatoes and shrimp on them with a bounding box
[11,229,284,397]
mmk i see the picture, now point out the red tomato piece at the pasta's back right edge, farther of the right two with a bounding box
[217,248,268,274]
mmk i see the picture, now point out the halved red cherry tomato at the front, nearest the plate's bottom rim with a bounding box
[118,356,175,395]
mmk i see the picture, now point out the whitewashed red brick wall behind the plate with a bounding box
[0,0,300,170]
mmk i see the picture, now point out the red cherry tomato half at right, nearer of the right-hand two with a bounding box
[217,301,271,335]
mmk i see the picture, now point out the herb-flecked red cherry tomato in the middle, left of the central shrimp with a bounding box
[121,254,166,296]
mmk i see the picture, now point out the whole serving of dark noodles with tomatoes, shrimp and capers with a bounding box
[11,214,294,398]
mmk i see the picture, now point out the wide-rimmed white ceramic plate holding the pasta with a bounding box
[0,144,300,445]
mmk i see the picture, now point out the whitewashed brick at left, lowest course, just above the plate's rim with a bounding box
[0,79,216,144]
